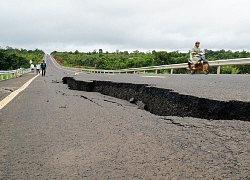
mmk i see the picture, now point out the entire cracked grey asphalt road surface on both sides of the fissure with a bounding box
[0,56,250,180]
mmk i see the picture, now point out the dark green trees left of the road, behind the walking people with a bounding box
[0,47,45,70]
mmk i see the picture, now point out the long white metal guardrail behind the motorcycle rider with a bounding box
[79,58,250,74]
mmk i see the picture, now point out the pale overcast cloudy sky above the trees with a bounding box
[0,0,250,54]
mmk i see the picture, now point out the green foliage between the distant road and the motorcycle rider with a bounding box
[51,51,187,69]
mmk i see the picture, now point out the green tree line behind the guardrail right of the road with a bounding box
[51,49,250,74]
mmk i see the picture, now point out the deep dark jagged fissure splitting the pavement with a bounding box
[62,77,250,121]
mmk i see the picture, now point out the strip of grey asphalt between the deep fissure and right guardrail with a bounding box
[74,73,250,102]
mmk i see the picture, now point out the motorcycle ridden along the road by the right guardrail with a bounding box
[187,53,209,74]
